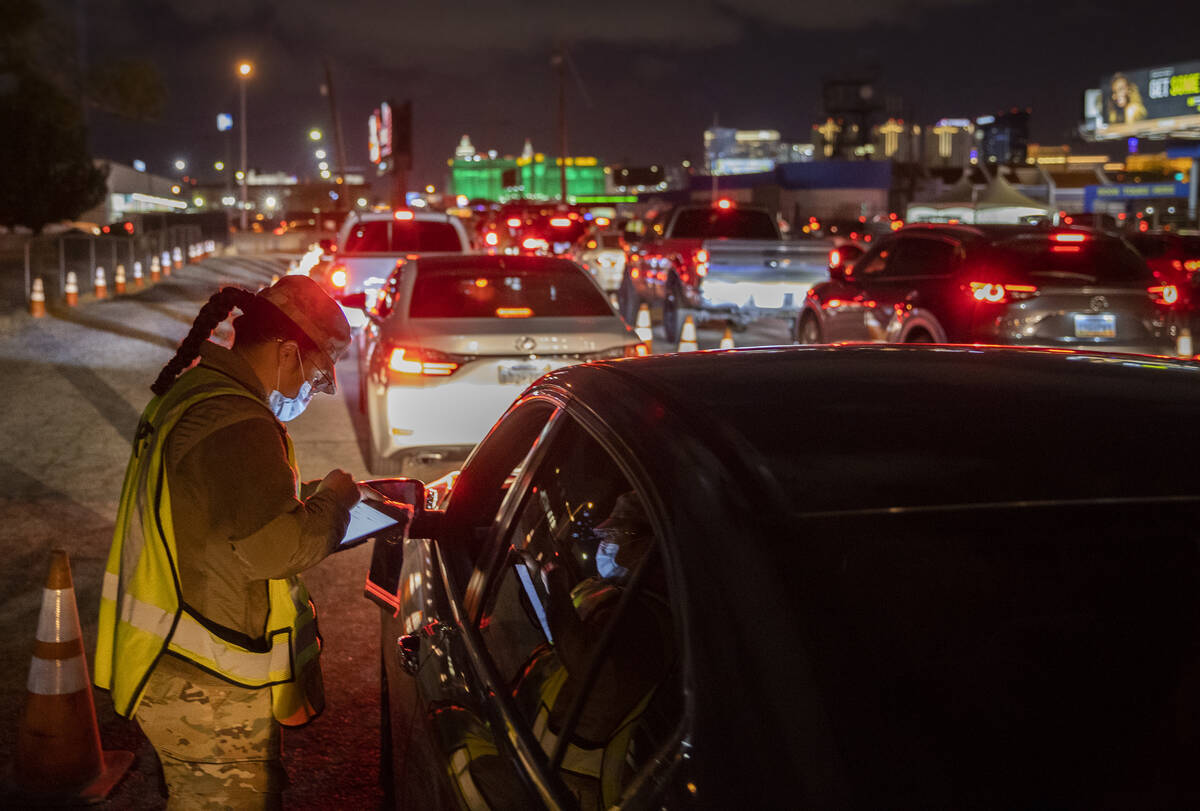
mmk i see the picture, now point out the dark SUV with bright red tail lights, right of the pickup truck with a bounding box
[796,224,1182,354]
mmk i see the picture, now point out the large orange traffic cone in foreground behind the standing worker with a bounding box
[13,549,133,804]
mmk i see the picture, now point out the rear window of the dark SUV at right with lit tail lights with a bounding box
[970,235,1153,286]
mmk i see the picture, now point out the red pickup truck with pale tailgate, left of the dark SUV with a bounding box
[617,206,833,343]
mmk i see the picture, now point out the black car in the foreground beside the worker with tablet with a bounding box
[367,347,1200,809]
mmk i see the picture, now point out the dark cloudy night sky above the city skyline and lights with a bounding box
[54,0,1200,187]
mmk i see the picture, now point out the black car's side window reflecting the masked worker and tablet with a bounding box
[479,419,683,809]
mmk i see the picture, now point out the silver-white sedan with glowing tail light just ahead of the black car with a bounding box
[343,256,647,481]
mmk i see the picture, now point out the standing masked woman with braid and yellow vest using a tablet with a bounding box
[92,276,359,809]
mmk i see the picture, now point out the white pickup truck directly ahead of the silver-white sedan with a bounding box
[308,209,470,329]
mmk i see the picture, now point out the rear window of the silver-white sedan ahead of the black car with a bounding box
[408,263,612,318]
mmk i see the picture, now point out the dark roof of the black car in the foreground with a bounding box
[547,346,1200,512]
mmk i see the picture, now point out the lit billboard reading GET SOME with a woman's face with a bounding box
[1084,61,1200,139]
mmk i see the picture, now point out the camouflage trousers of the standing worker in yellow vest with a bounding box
[134,656,287,811]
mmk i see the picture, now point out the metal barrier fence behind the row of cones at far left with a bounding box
[0,226,207,308]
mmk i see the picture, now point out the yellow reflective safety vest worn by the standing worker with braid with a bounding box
[92,366,324,726]
